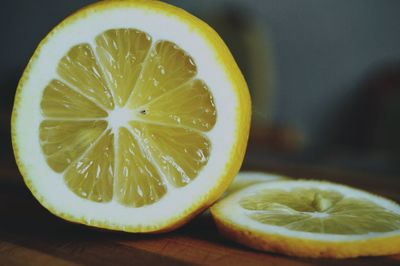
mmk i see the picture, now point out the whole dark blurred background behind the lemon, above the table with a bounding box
[0,0,400,183]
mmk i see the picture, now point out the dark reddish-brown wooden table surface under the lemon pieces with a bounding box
[0,159,400,266]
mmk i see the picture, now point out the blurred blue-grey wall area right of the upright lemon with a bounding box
[168,0,400,149]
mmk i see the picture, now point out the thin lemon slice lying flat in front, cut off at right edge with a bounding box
[211,180,400,258]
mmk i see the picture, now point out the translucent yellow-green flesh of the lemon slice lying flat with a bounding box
[240,188,400,235]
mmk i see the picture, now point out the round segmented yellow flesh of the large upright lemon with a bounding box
[39,29,216,207]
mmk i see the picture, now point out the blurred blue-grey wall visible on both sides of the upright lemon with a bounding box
[0,0,400,162]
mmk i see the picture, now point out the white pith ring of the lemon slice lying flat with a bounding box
[212,181,400,242]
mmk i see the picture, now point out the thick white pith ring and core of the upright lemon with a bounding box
[14,5,239,228]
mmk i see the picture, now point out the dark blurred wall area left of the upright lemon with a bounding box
[0,0,95,165]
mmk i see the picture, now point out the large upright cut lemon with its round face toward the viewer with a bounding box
[12,0,251,232]
